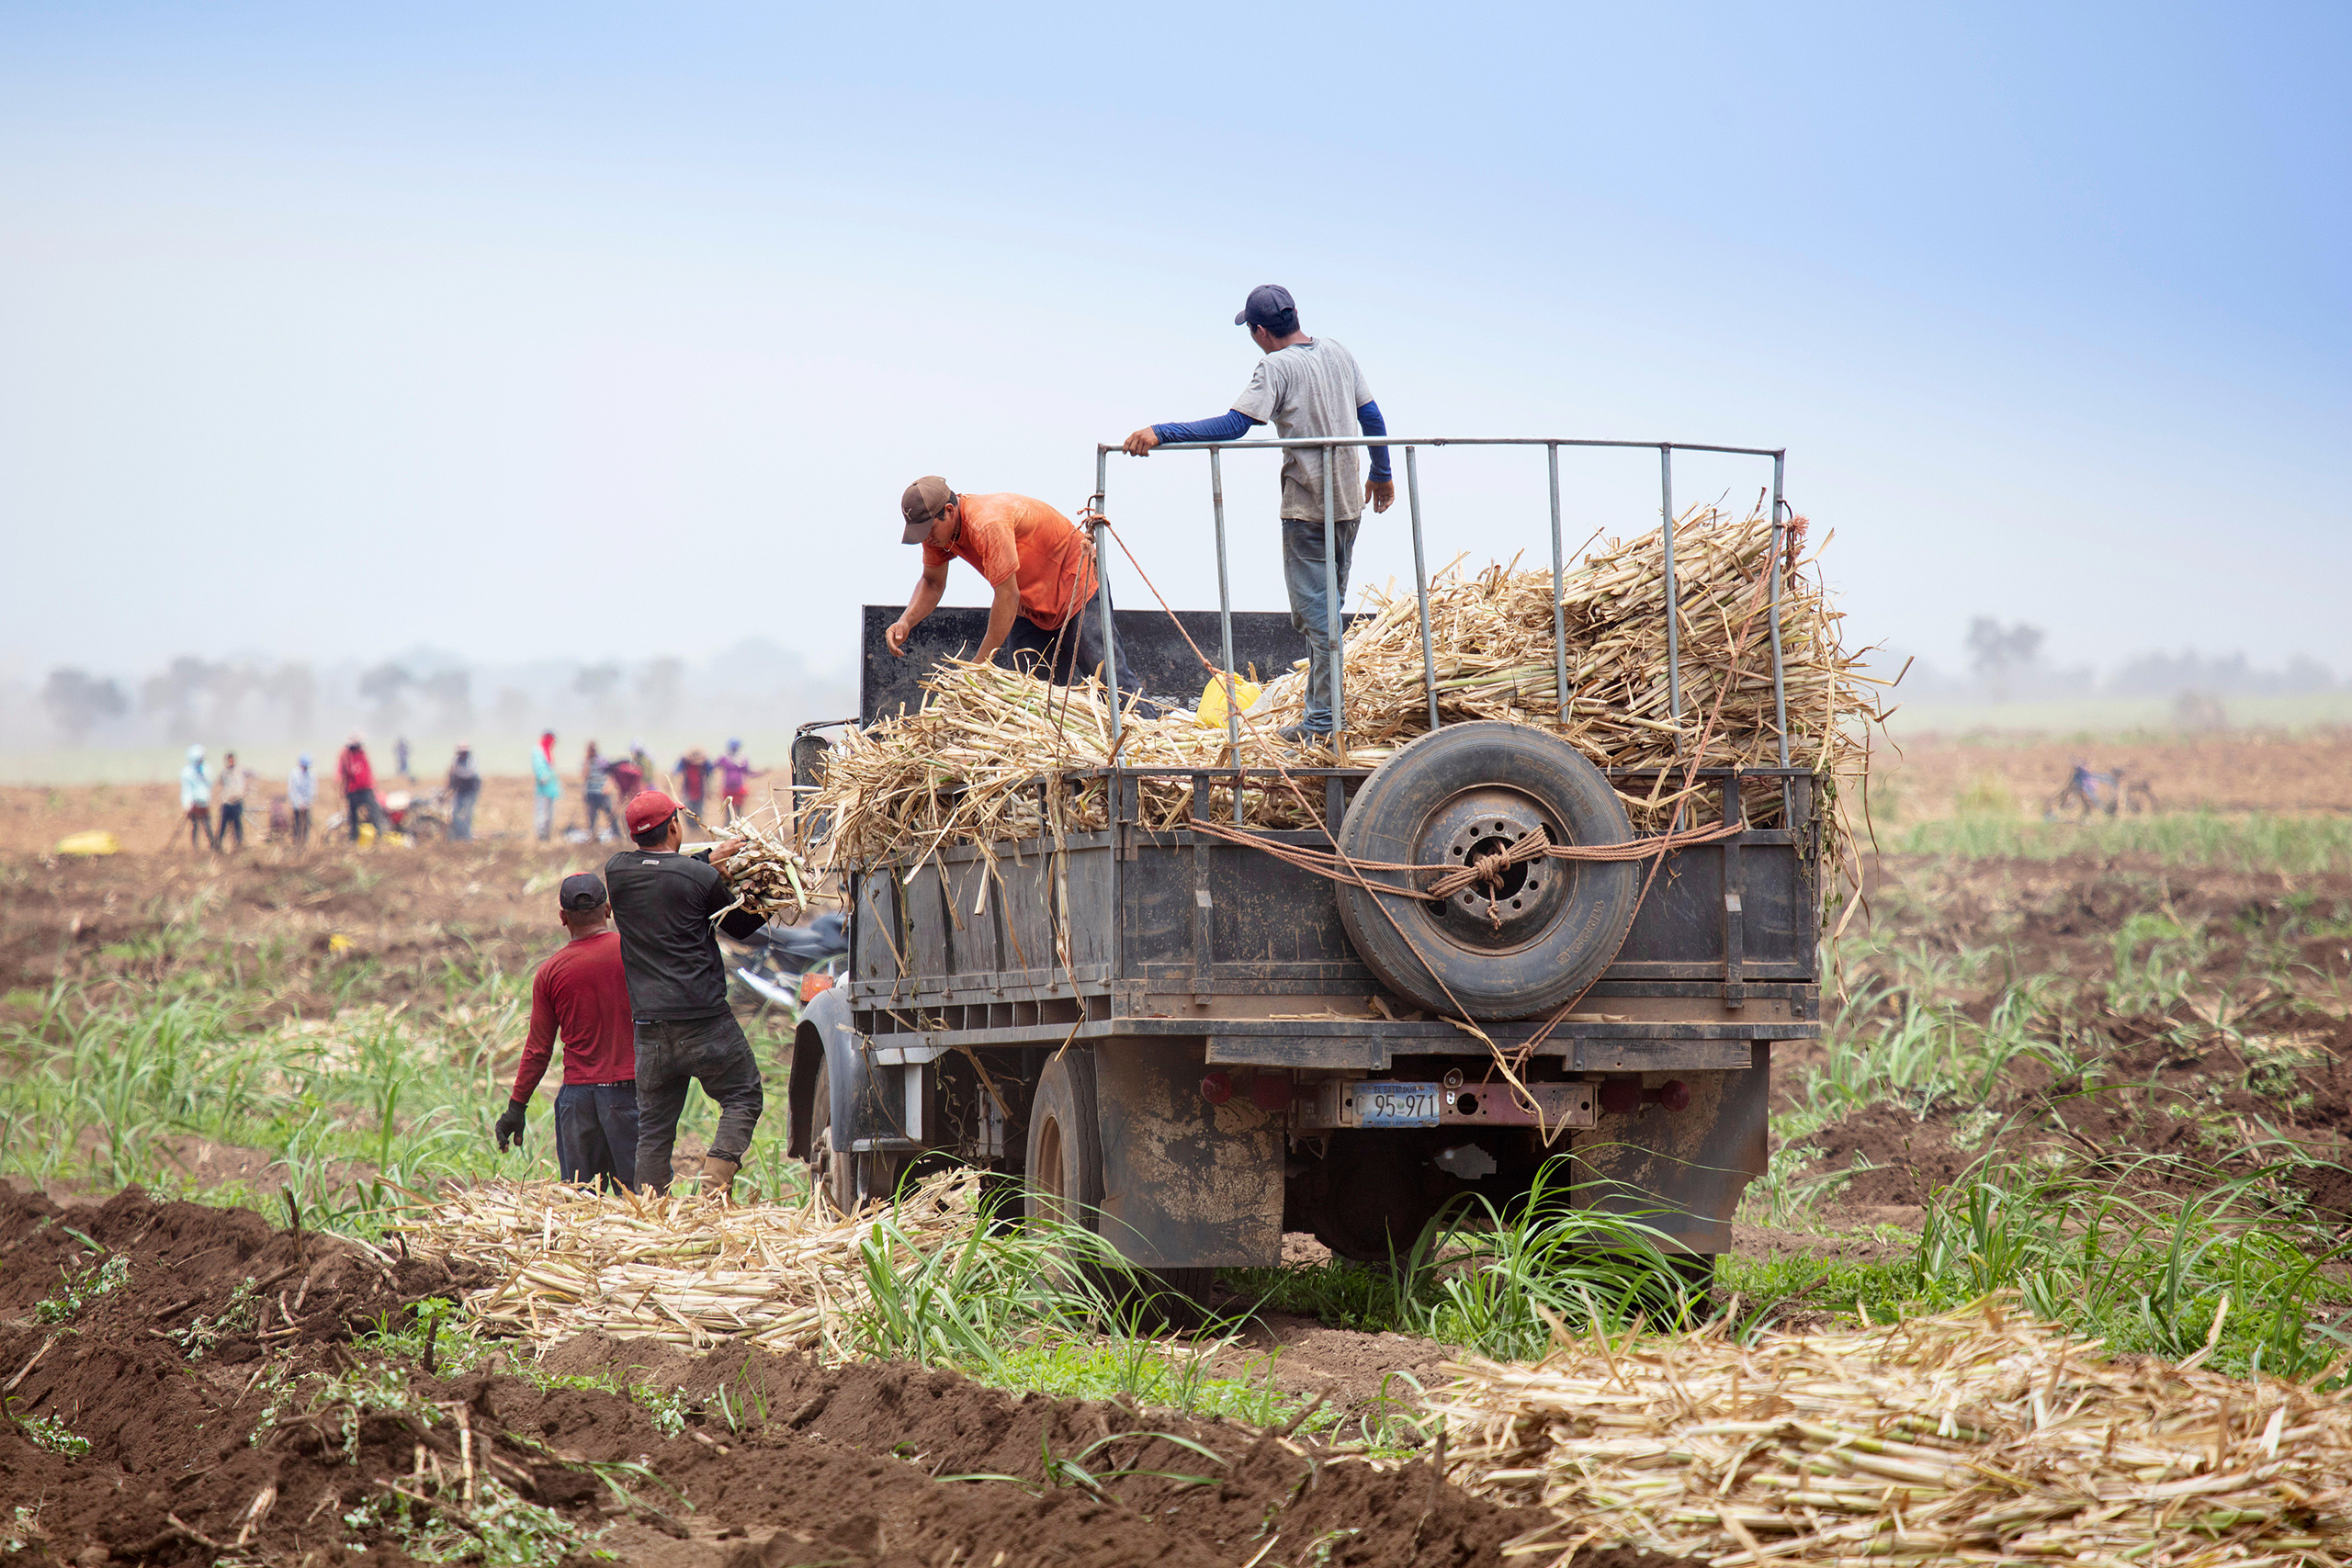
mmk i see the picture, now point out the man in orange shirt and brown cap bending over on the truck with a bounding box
[885,475,1138,698]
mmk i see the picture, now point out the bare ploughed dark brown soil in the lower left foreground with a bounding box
[0,1192,1618,1568]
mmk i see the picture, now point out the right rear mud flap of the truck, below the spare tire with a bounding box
[1569,1039,1771,1253]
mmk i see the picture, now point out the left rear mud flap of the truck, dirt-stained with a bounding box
[1093,1039,1282,1269]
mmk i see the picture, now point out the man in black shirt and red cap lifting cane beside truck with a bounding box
[605,790,764,1199]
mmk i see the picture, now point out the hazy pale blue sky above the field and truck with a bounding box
[0,3,2352,672]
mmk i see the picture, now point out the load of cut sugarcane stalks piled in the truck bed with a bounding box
[802,508,1879,863]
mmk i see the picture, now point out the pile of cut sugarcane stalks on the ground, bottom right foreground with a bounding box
[1435,1298,2352,1568]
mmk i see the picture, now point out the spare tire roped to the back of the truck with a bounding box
[1339,719,1642,1018]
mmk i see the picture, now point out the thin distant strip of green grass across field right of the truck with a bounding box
[1877,811,2352,874]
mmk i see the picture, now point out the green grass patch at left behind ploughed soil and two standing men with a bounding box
[0,931,807,1239]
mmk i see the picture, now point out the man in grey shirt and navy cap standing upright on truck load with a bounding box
[1126,285,1397,740]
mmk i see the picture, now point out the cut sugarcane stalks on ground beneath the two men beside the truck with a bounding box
[395,1170,978,1357]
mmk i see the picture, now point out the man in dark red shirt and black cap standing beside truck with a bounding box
[496,872,638,1192]
